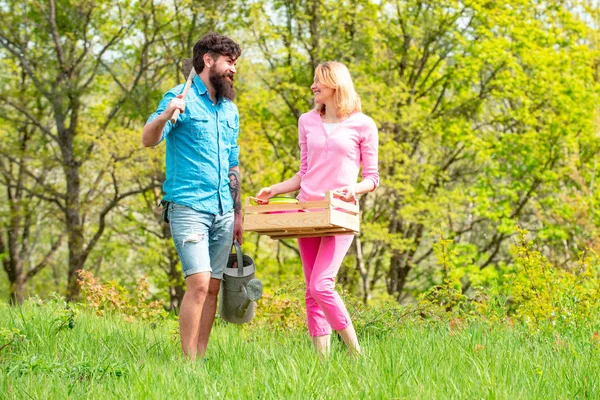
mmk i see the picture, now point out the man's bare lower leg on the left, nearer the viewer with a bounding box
[179,272,214,360]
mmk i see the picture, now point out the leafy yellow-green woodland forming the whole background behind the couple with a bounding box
[0,0,600,310]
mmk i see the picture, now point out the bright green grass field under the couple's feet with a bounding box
[0,302,600,399]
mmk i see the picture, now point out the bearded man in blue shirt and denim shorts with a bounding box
[142,33,243,359]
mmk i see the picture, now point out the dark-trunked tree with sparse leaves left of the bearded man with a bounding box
[0,0,173,298]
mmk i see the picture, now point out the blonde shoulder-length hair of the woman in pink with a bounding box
[315,61,361,117]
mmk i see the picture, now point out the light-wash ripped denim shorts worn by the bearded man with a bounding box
[169,203,234,279]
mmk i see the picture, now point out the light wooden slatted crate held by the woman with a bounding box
[243,192,360,239]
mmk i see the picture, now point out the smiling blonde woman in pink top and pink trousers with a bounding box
[256,61,379,354]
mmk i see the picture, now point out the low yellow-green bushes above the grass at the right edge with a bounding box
[420,229,600,331]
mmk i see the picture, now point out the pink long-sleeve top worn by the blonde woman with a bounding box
[298,110,379,201]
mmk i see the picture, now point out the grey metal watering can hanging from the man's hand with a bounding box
[219,240,262,324]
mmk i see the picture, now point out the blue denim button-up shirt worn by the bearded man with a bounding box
[147,76,239,215]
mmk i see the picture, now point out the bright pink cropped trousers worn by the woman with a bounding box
[298,235,354,337]
